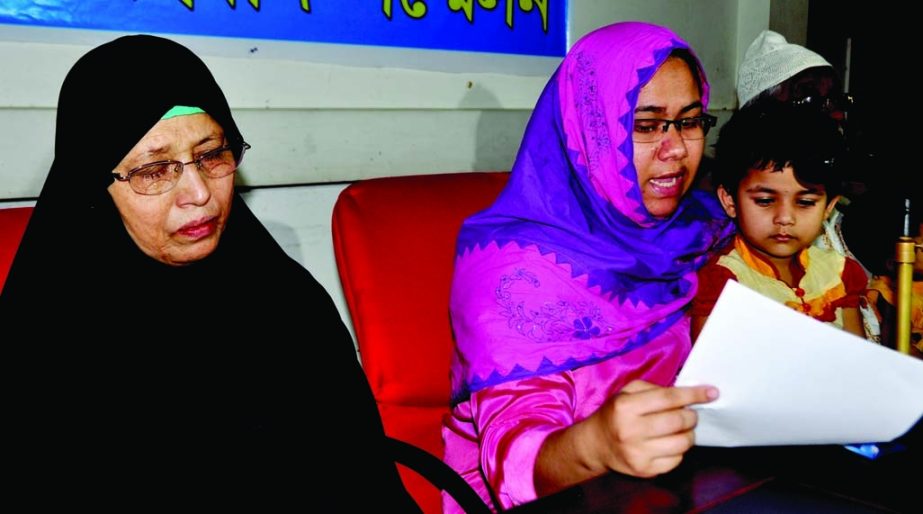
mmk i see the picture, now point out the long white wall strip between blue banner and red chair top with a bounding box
[0,25,560,198]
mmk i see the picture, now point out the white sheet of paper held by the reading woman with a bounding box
[676,281,923,446]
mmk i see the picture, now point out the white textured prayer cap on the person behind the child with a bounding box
[737,30,832,106]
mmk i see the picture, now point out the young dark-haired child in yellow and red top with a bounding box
[692,105,867,340]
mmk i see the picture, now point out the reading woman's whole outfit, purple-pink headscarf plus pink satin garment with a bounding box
[443,22,733,512]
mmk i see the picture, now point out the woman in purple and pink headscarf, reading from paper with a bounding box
[443,22,733,512]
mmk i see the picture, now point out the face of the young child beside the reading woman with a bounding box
[718,165,835,267]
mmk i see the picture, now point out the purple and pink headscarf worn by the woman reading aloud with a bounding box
[450,22,733,403]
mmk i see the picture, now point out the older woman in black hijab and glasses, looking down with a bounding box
[0,36,415,504]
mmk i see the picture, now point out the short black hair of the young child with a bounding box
[714,103,846,200]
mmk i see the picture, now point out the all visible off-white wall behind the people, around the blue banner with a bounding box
[0,0,807,348]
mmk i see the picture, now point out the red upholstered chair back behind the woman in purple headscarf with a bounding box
[333,172,509,513]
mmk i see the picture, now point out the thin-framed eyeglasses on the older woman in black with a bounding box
[112,142,250,195]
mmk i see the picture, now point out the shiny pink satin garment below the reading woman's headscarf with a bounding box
[442,318,691,513]
